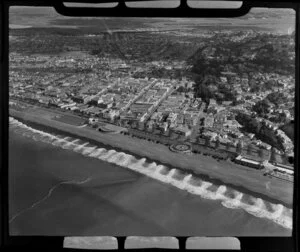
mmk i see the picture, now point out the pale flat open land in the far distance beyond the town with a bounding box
[9,7,295,33]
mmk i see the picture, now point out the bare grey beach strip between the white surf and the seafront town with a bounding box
[9,109,293,208]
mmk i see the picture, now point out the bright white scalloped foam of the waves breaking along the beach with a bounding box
[10,118,293,229]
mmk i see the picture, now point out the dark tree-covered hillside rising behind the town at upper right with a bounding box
[188,35,295,101]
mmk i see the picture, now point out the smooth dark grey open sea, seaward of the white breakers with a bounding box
[9,132,292,236]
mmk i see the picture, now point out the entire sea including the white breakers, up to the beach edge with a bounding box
[9,118,292,236]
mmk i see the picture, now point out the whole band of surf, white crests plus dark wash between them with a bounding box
[9,117,292,229]
